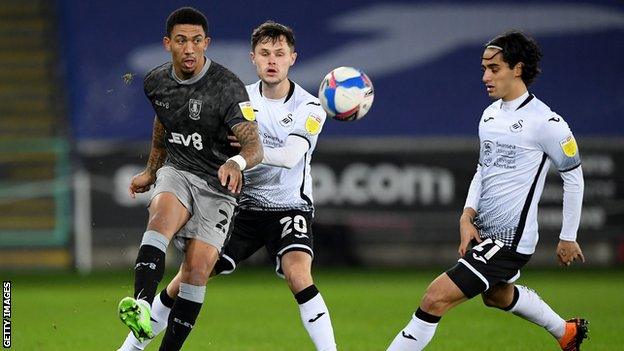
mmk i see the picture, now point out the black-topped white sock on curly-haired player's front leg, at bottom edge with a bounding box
[387,308,440,351]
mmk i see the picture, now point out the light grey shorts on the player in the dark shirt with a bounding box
[148,166,236,252]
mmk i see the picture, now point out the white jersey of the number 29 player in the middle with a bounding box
[239,81,326,211]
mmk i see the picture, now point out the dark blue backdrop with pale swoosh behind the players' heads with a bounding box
[59,0,624,140]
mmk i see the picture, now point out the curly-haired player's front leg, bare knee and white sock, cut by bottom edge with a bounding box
[388,273,468,351]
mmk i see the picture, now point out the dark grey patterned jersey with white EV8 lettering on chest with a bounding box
[144,59,254,193]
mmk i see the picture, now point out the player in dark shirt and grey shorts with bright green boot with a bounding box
[119,7,263,350]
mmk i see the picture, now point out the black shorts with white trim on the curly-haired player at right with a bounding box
[446,239,531,298]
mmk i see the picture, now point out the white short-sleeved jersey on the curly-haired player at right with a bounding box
[475,93,581,254]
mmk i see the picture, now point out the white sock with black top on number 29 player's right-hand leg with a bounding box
[295,285,336,351]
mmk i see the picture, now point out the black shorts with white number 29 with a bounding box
[215,210,314,278]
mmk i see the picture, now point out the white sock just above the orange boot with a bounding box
[509,285,566,340]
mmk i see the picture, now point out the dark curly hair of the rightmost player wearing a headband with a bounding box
[485,30,542,87]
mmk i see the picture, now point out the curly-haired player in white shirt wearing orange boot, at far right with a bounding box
[388,31,587,351]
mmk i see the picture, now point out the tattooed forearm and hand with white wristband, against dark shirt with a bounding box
[219,122,263,193]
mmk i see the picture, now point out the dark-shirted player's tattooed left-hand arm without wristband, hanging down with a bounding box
[128,117,167,198]
